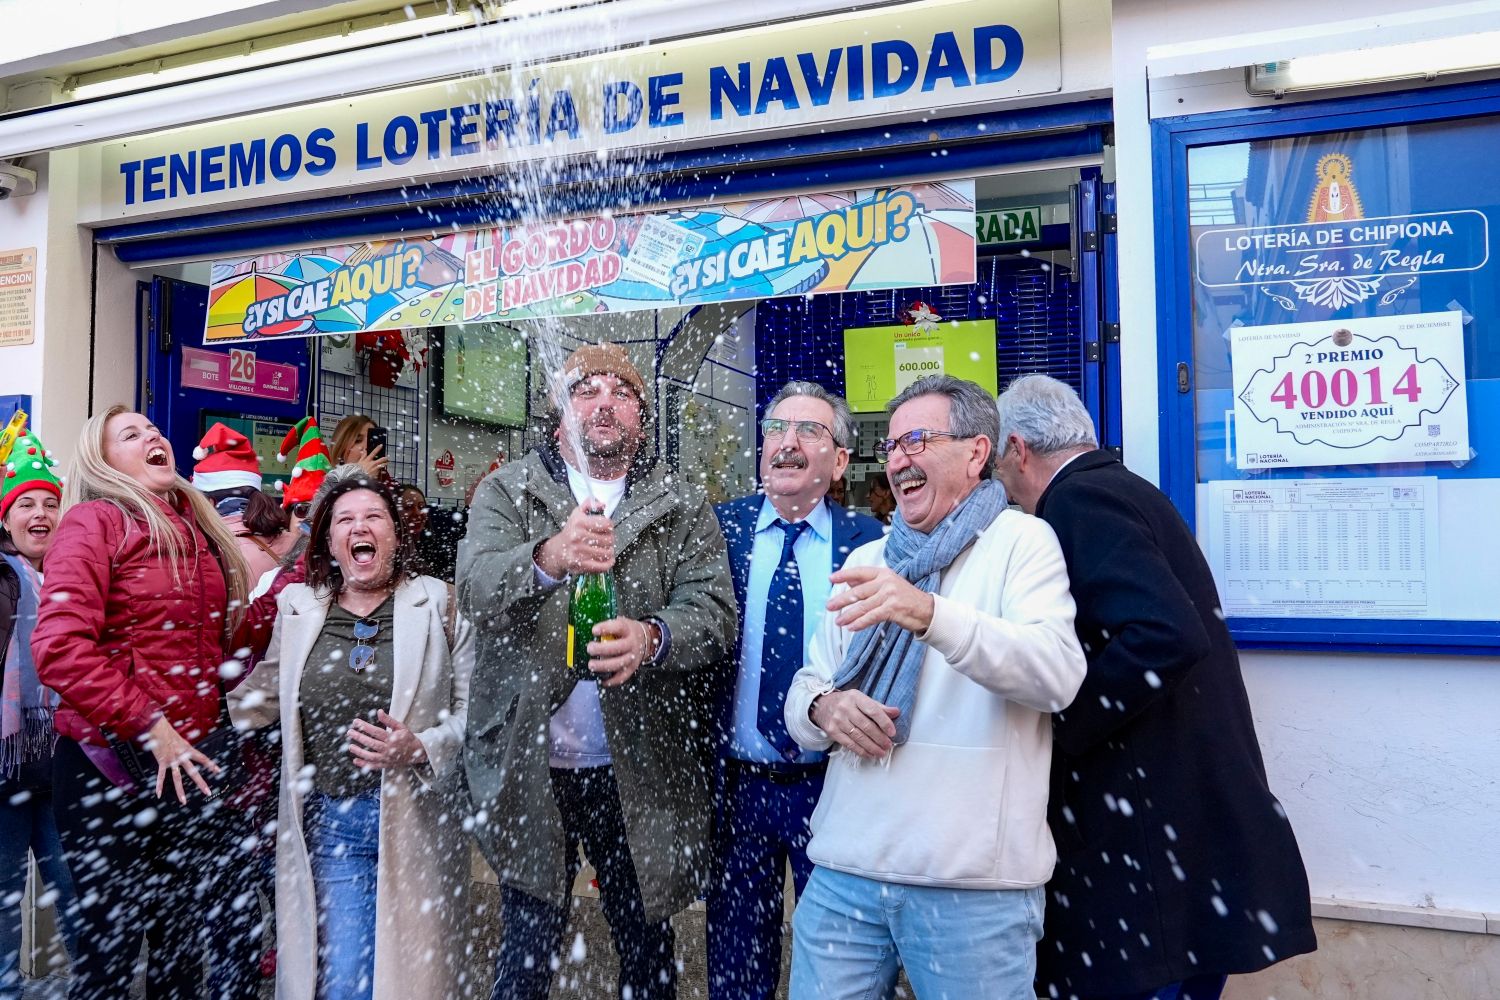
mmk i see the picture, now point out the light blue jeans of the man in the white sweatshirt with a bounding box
[789,867,1044,1000]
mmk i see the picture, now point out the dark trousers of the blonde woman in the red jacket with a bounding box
[53,738,237,1000]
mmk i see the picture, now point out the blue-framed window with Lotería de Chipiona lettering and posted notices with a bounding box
[1164,82,1500,652]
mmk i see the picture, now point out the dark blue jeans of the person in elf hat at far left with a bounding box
[0,759,78,1000]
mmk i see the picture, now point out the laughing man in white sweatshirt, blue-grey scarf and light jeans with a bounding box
[786,375,1085,1000]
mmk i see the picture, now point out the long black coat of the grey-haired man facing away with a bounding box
[1037,451,1317,997]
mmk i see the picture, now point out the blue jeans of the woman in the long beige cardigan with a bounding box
[303,792,380,1000]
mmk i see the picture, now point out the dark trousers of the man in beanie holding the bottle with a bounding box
[491,768,677,1000]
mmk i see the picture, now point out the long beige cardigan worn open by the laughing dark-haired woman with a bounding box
[231,577,474,1000]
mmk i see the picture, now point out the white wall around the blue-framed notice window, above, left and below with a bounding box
[1112,0,1500,912]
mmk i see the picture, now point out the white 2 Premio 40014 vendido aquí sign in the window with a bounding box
[1230,312,1469,469]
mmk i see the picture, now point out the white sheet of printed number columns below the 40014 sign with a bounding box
[1206,477,1440,618]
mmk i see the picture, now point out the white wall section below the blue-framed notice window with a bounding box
[1241,654,1500,912]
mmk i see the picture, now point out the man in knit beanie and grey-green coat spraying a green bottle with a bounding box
[458,343,735,1000]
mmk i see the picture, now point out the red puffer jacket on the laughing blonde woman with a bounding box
[32,501,228,745]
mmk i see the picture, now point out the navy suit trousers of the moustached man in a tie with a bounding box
[707,762,824,1000]
